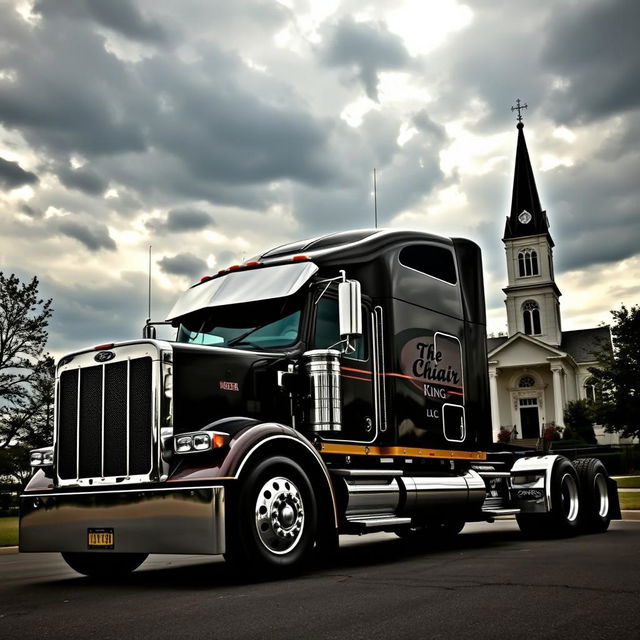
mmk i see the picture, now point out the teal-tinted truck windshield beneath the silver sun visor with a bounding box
[176,309,302,349]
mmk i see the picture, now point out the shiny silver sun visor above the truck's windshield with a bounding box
[167,262,318,321]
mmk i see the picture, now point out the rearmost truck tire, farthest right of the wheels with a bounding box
[573,458,611,533]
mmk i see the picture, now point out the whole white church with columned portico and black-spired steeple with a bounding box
[487,116,618,444]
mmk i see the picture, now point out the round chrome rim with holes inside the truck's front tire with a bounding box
[255,476,304,555]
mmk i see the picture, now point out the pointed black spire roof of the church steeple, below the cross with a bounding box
[503,122,553,246]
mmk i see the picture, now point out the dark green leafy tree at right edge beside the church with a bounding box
[590,305,640,437]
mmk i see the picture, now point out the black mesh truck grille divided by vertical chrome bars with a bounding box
[57,357,153,481]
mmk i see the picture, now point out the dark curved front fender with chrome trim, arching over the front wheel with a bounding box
[167,416,338,528]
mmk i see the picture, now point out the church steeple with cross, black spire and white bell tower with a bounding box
[502,100,562,346]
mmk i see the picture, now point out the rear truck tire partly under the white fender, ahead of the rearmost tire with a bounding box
[516,457,580,538]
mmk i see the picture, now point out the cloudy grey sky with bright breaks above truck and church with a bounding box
[0,0,640,355]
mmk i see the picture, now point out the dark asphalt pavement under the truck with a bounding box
[0,521,640,640]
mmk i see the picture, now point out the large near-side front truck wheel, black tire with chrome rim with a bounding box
[225,457,318,573]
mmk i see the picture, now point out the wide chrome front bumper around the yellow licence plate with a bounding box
[20,486,225,554]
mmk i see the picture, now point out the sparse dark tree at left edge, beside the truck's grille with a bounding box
[0,271,55,449]
